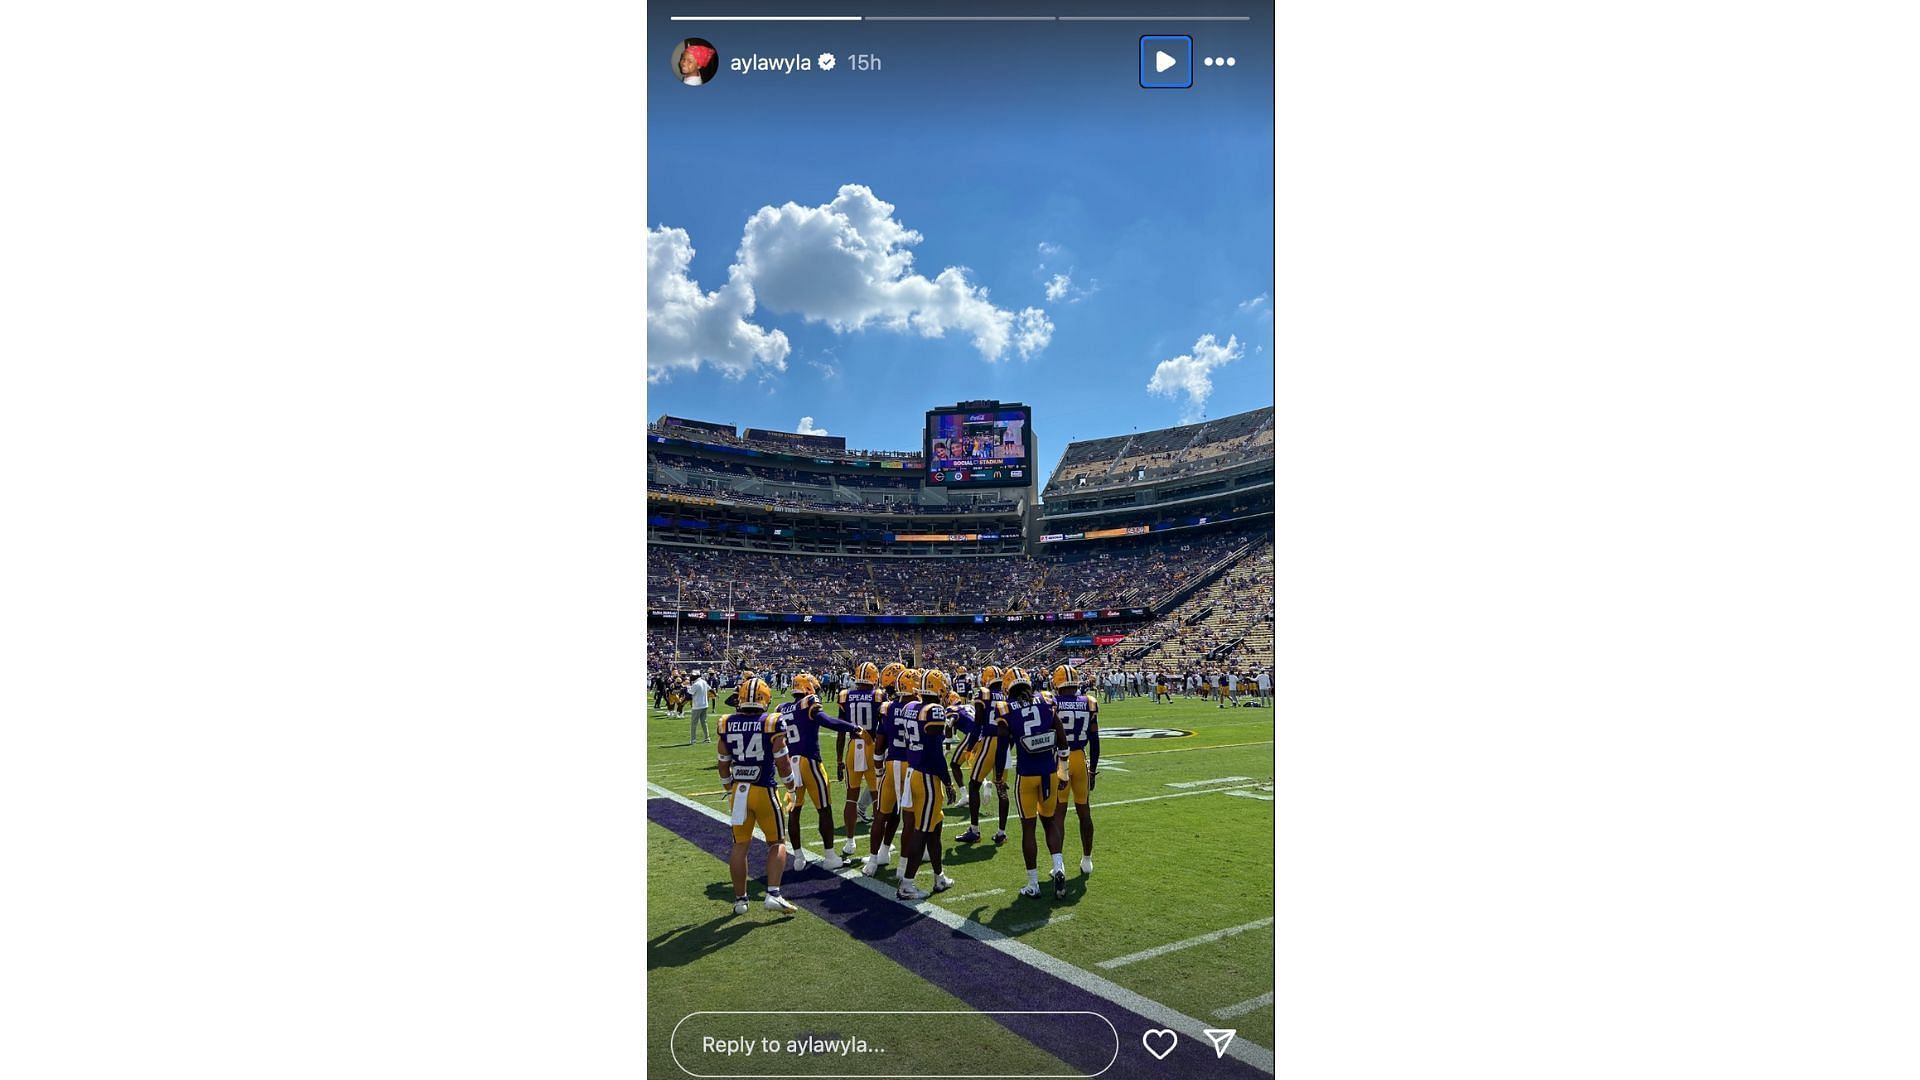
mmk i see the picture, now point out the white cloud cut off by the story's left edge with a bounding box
[647,225,789,382]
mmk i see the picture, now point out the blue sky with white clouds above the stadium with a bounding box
[647,8,1273,471]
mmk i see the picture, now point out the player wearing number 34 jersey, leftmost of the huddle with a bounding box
[718,676,797,915]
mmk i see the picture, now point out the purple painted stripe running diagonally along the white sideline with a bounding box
[647,799,1271,1080]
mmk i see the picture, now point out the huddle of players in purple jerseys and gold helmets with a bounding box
[718,663,1100,915]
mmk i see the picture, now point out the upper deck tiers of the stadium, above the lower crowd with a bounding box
[647,407,1273,559]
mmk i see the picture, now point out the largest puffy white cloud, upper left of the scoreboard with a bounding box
[733,184,1052,361]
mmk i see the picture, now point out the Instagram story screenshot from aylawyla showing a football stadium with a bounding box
[645,0,1277,1078]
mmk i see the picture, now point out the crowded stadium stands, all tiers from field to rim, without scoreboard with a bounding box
[647,407,1273,680]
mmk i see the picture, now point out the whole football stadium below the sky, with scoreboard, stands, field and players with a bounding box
[647,400,1275,1076]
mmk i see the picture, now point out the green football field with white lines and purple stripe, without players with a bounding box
[645,698,1273,1076]
